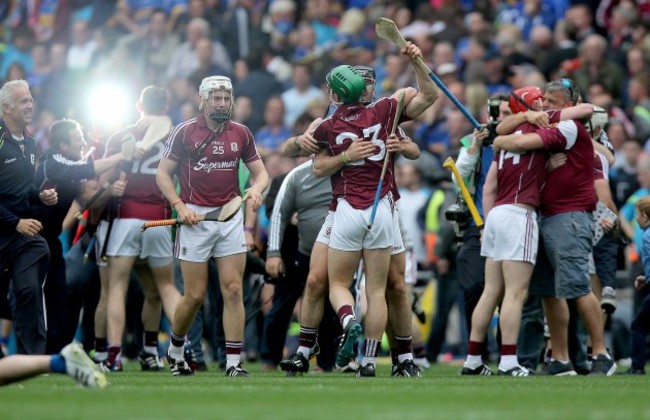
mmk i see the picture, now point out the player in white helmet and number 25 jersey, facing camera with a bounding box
[156,76,269,376]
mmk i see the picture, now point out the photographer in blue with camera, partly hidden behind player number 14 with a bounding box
[445,97,511,346]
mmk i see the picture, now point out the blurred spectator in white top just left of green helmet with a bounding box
[282,63,323,127]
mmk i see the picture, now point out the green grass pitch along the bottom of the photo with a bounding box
[0,363,650,420]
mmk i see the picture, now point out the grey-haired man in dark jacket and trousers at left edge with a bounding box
[0,80,57,354]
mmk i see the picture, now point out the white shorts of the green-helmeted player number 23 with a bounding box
[329,197,394,251]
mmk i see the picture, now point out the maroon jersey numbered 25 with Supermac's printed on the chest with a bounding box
[163,114,260,207]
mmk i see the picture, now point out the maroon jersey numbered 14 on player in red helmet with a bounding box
[494,123,548,207]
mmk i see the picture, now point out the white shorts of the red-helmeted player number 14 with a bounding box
[481,204,539,264]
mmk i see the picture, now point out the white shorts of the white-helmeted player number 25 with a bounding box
[174,204,247,262]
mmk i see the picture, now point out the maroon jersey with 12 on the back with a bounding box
[105,125,171,220]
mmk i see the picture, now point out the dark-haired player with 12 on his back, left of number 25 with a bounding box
[98,86,180,371]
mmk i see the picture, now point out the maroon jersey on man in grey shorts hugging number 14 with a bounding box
[537,110,597,216]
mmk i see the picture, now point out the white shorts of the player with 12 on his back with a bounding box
[106,219,173,265]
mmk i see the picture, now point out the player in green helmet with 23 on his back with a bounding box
[314,43,437,376]
